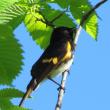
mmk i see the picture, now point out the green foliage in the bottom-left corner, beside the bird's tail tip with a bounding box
[0,88,28,110]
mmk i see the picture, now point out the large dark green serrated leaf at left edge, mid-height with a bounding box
[0,25,23,85]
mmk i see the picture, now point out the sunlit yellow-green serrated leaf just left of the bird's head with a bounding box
[24,10,52,48]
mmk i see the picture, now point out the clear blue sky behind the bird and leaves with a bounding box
[13,0,110,110]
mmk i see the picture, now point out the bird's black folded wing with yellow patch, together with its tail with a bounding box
[19,43,68,106]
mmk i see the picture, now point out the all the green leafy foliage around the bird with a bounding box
[0,0,98,110]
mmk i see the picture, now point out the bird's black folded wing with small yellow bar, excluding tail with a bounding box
[31,43,67,83]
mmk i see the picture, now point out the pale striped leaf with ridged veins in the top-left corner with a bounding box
[0,4,26,29]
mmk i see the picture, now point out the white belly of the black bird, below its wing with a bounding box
[50,59,73,77]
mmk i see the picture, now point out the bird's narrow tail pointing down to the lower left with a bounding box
[19,78,38,107]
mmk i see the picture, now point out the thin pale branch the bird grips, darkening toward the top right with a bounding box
[55,0,107,110]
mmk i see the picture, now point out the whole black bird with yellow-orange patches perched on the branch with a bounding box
[19,27,75,106]
